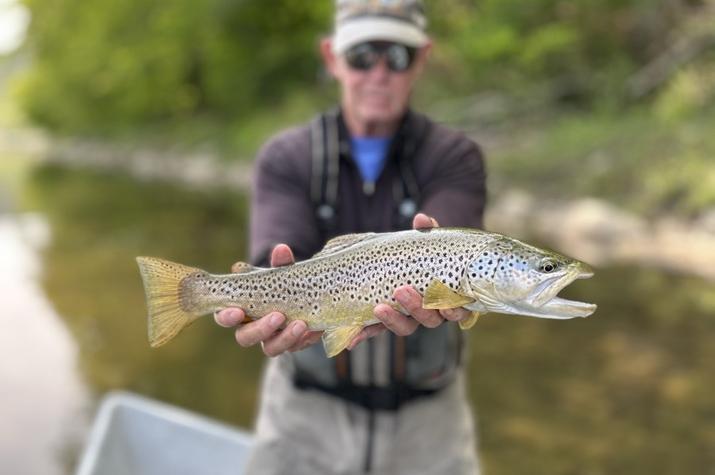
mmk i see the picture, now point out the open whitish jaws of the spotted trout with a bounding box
[529,263,598,319]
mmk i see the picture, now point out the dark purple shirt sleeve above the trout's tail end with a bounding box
[250,140,320,266]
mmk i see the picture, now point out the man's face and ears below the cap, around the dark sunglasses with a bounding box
[321,40,430,128]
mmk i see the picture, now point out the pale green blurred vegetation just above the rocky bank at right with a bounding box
[489,105,715,217]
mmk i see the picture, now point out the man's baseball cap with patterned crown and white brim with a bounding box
[333,0,428,54]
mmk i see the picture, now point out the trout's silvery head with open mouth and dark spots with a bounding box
[465,236,596,319]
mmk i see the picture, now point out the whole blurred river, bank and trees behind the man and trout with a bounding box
[0,0,715,475]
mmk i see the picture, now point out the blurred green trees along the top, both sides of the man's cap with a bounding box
[15,0,693,133]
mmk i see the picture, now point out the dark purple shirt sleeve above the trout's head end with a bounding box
[421,138,486,228]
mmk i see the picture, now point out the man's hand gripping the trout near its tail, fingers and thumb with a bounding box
[214,244,322,356]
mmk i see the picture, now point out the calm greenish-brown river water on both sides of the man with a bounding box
[0,157,715,474]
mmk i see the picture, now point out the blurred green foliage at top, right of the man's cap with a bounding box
[429,0,648,95]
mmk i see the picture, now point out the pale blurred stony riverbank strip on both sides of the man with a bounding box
[0,128,715,281]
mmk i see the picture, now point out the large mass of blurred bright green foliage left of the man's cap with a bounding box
[14,0,331,133]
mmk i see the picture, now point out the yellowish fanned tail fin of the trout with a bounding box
[137,257,203,348]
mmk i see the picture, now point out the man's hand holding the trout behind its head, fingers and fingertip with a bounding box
[348,213,469,350]
